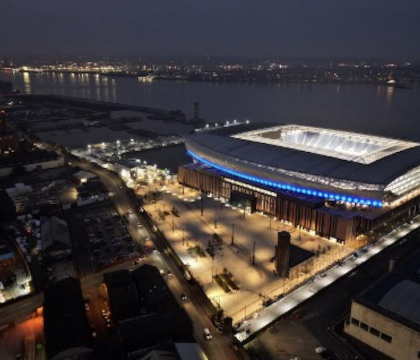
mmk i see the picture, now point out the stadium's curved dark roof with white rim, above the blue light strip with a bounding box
[186,125,420,202]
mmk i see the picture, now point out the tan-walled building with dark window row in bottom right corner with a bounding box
[344,253,420,360]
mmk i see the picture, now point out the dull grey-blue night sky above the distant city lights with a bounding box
[0,0,420,61]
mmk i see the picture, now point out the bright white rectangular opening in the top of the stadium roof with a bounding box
[233,125,419,164]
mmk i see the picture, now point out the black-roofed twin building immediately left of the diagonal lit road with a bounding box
[104,264,199,359]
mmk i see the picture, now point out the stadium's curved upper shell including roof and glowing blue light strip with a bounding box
[186,125,420,207]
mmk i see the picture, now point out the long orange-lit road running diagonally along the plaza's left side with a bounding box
[69,157,247,360]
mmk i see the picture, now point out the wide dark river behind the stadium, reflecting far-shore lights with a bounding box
[0,72,420,141]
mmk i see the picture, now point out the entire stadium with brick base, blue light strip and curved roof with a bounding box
[178,125,420,242]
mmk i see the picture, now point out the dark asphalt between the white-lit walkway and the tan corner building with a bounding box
[256,230,420,360]
